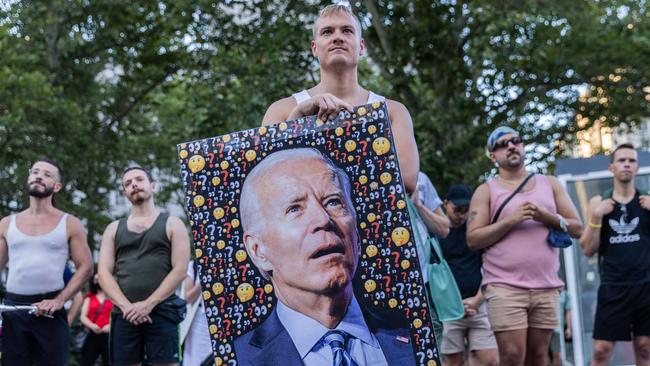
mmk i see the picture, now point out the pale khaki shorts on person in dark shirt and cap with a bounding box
[440,303,497,355]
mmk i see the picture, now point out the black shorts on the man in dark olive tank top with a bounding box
[110,311,180,366]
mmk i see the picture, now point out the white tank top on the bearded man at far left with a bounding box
[7,214,69,295]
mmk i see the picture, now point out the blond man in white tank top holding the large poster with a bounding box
[262,4,420,192]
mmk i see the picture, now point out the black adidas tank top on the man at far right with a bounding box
[598,191,650,285]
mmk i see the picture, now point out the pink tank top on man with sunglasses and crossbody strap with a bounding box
[482,175,564,289]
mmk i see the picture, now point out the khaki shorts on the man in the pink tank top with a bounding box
[483,284,560,332]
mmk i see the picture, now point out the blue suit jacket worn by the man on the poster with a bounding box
[235,310,415,366]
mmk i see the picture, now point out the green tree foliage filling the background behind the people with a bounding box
[0,0,650,243]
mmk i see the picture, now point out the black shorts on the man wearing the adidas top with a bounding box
[594,282,650,342]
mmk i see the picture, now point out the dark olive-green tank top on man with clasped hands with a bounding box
[113,213,172,311]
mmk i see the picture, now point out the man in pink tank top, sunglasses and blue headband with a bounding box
[467,127,582,365]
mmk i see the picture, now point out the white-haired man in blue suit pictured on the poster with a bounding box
[235,148,415,366]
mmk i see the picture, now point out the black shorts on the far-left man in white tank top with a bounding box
[2,292,70,366]
